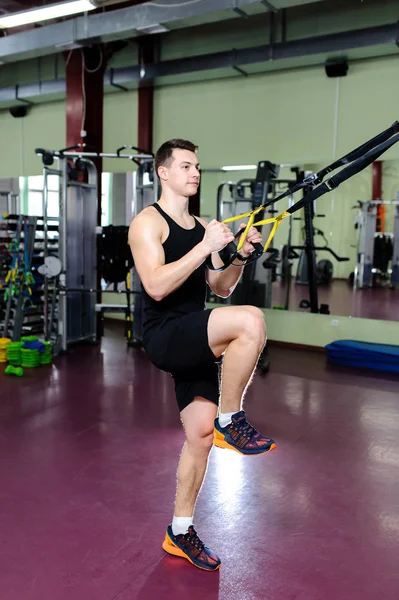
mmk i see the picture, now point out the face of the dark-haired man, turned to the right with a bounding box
[158,149,200,197]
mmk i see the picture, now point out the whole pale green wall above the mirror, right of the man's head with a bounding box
[154,57,399,168]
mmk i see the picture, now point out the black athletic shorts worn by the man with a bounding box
[144,309,219,411]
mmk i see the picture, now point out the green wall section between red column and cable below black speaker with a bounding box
[154,62,335,168]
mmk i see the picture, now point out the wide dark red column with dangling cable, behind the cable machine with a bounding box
[65,46,107,225]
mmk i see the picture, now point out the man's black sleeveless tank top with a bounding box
[143,203,206,339]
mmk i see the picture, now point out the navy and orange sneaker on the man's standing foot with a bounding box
[162,525,221,571]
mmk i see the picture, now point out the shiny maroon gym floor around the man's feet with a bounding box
[0,328,399,600]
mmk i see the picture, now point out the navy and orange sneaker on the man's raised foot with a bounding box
[213,410,276,454]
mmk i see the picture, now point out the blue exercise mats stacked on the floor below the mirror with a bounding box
[326,340,399,373]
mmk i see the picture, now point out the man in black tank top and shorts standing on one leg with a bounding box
[129,139,275,571]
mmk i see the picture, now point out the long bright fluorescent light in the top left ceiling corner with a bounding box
[0,0,96,29]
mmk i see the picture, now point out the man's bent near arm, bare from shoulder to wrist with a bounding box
[129,212,210,301]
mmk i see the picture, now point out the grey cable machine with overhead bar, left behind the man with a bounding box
[36,146,157,352]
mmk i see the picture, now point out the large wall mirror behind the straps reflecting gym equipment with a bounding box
[201,161,399,321]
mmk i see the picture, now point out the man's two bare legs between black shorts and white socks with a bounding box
[175,306,266,517]
